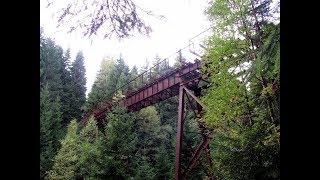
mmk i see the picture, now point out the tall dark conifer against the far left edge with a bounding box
[40,34,67,178]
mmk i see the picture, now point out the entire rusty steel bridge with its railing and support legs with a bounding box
[82,27,215,180]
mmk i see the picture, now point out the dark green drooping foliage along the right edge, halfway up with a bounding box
[250,24,280,124]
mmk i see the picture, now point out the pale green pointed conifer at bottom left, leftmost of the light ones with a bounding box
[49,120,79,179]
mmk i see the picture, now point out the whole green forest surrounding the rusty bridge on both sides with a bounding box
[40,0,280,180]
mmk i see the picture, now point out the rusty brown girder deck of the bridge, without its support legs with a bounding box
[85,61,201,121]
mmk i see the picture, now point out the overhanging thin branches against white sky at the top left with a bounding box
[48,0,164,38]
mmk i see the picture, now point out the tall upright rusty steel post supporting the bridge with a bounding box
[175,85,184,180]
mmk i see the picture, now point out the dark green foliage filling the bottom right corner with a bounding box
[211,120,280,179]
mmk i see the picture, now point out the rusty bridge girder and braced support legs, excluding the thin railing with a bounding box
[83,60,213,179]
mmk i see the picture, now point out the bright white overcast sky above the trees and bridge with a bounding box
[40,0,210,94]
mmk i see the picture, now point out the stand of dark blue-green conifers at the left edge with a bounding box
[40,31,86,178]
